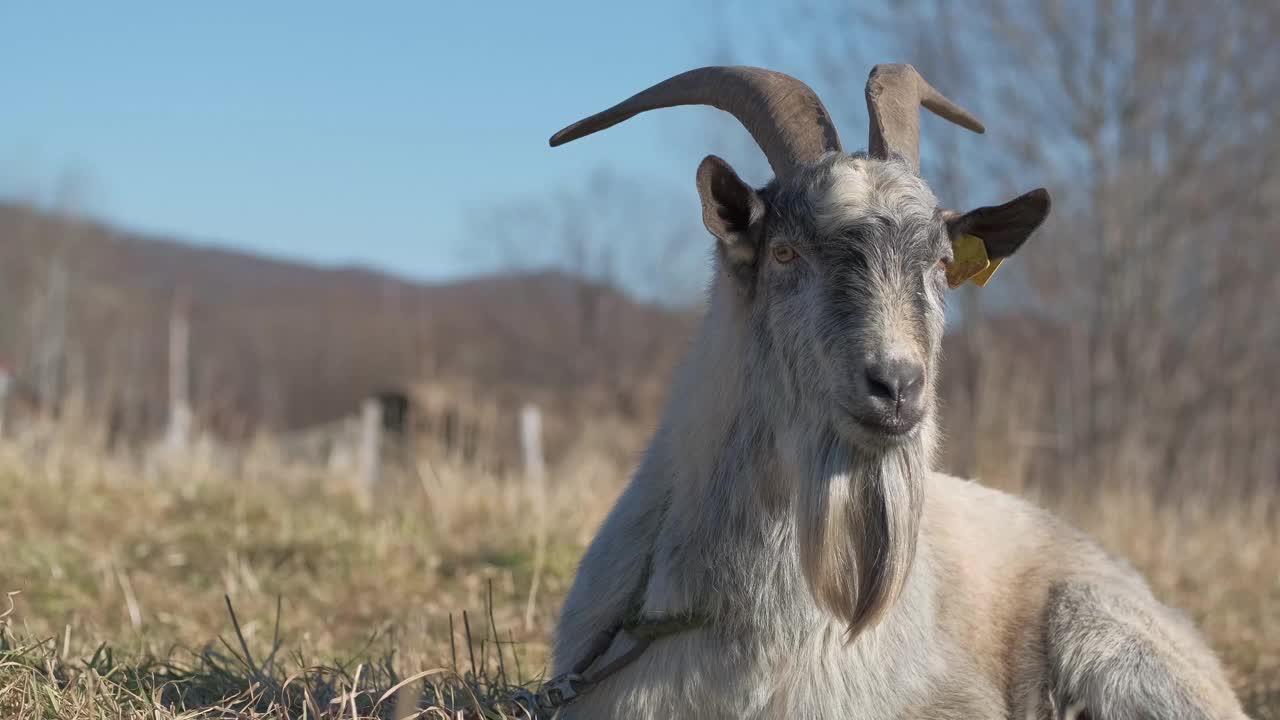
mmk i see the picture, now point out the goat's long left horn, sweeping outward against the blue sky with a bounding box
[552,67,841,177]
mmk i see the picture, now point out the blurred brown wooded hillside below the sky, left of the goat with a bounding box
[0,204,691,436]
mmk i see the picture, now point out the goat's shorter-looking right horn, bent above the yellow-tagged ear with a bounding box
[867,65,987,169]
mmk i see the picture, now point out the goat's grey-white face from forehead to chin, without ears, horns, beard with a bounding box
[755,156,951,447]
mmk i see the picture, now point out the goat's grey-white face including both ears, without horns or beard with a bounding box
[699,152,1048,450]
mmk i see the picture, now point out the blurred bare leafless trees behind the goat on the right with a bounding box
[742,0,1280,487]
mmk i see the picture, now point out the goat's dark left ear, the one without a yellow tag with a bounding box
[698,155,764,268]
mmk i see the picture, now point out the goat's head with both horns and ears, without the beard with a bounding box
[550,65,1048,450]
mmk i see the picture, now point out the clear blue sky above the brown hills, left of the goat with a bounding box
[0,0,819,278]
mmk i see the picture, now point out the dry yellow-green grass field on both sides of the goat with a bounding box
[0,435,1280,720]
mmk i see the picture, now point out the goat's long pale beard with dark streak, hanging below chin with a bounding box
[796,430,928,639]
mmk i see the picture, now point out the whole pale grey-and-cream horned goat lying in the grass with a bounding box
[550,65,1244,720]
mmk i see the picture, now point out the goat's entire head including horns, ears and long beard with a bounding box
[552,65,1048,634]
